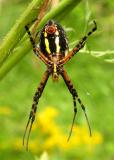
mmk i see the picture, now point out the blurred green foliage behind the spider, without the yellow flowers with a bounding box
[0,1,114,160]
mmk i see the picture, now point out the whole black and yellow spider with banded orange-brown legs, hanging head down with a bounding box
[23,20,97,150]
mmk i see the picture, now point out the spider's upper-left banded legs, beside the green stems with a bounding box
[25,25,52,65]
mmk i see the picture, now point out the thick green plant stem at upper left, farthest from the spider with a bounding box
[0,0,43,65]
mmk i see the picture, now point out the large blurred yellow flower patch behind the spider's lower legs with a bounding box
[29,107,103,153]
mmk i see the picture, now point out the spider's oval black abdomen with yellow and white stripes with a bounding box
[39,20,68,56]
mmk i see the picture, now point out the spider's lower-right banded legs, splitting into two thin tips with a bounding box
[61,69,91,141]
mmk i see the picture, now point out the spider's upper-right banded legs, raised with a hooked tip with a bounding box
[59,21,97,65]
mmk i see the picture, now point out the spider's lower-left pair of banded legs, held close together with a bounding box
[23,70,50,150]
